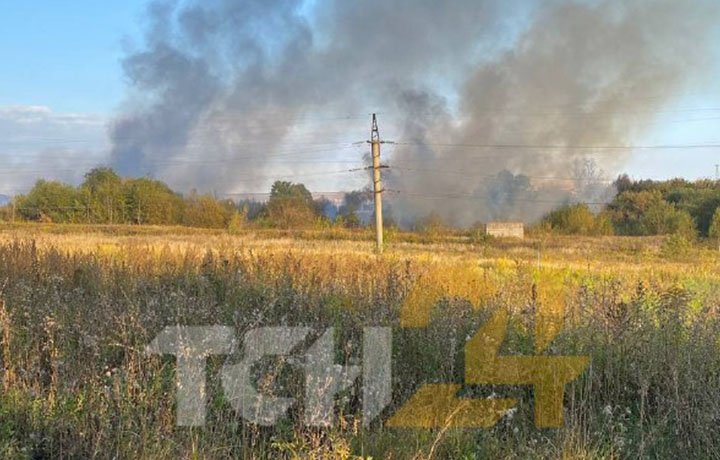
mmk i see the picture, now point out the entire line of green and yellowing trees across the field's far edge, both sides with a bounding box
[0,167,720,239]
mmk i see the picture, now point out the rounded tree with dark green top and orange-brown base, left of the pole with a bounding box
[267,181,318,228]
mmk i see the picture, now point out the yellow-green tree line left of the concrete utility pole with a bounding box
[0,167,366,230]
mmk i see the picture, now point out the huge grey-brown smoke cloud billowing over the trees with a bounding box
[111,0,720,225]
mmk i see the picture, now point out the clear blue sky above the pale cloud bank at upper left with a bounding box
[0,0,146,113]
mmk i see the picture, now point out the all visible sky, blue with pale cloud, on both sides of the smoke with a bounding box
[0,0,720,195]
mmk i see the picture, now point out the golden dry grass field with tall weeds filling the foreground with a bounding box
[0,224,720,459]
